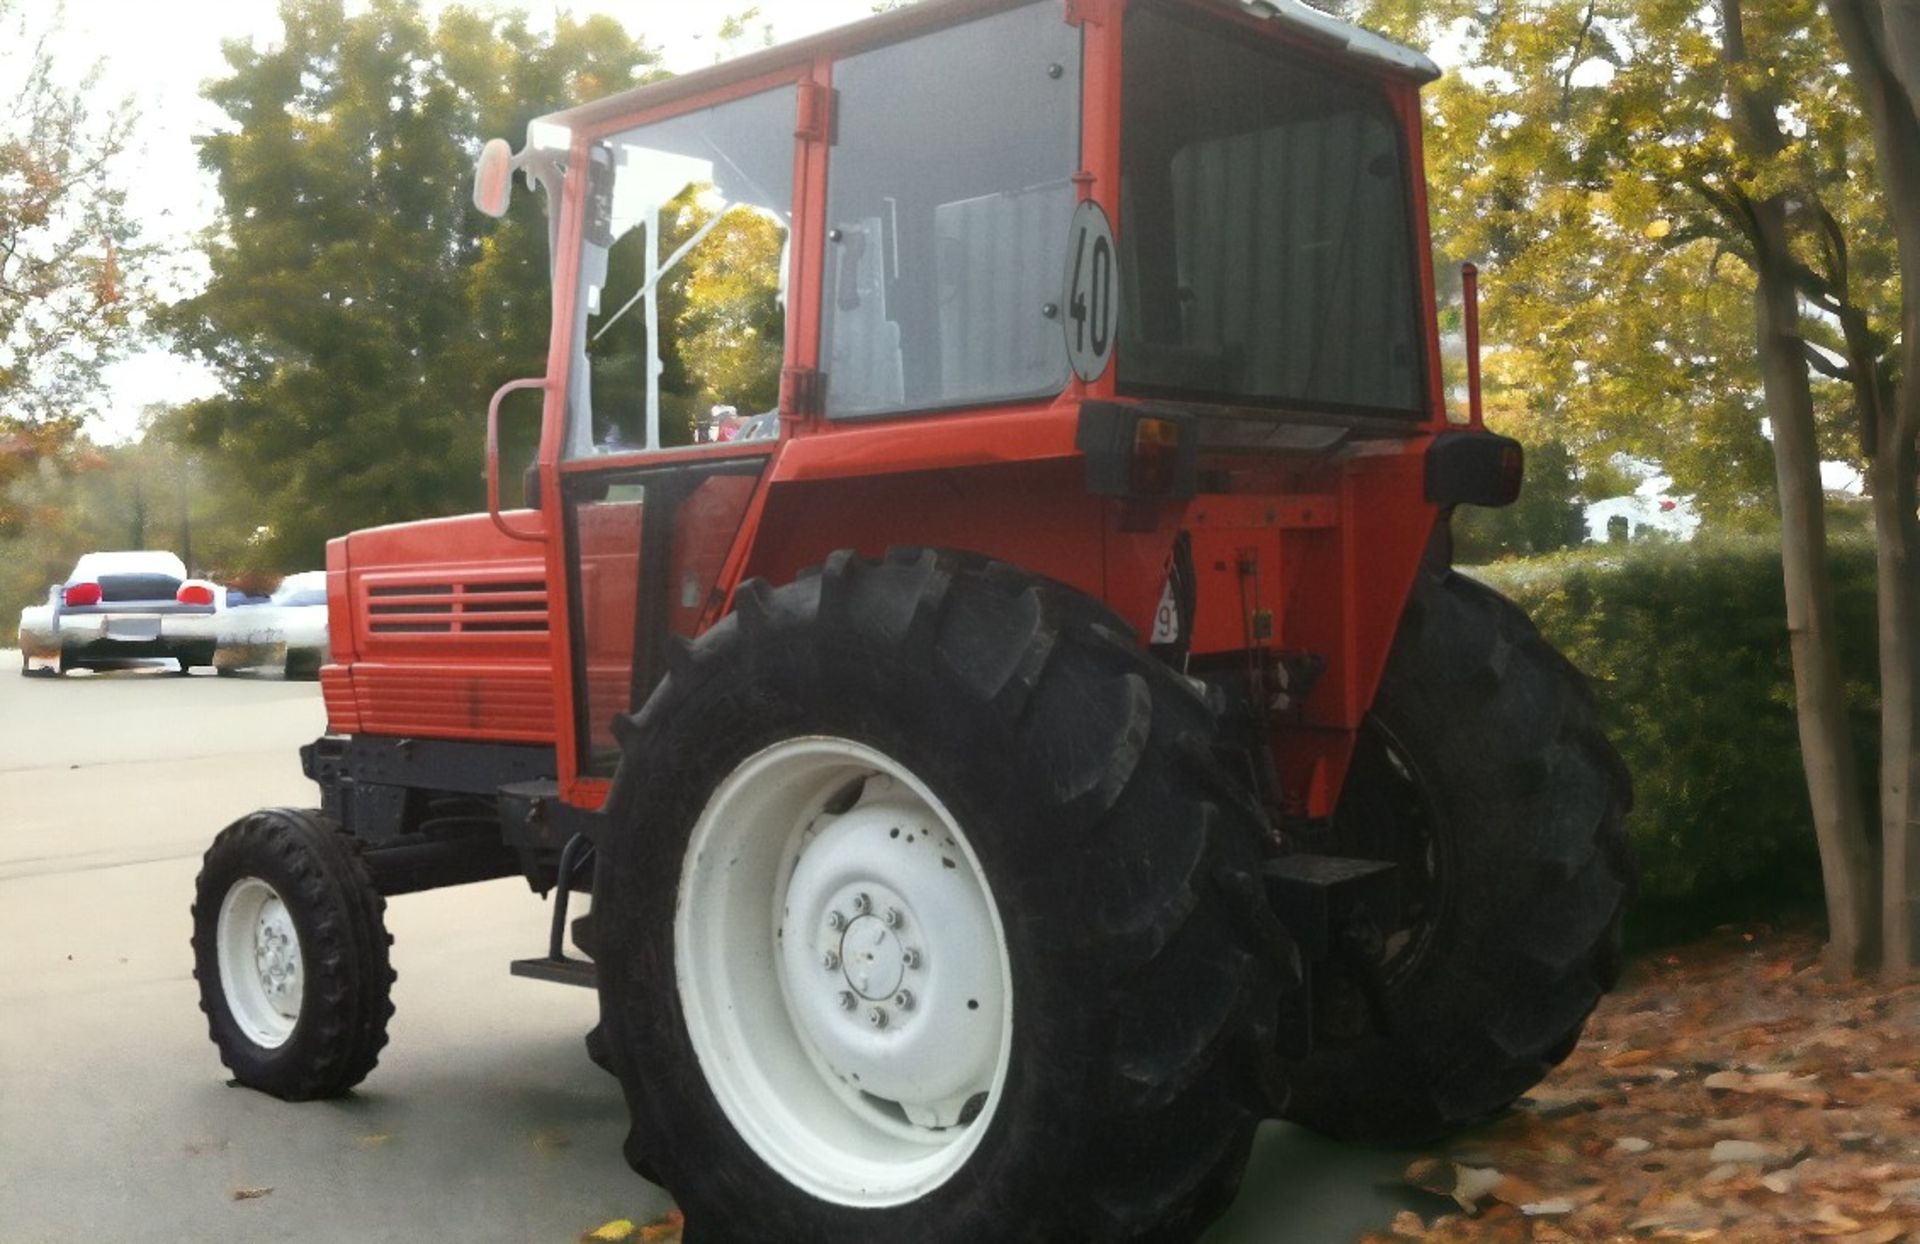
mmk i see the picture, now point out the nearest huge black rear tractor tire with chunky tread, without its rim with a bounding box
[593,549,1298,1244]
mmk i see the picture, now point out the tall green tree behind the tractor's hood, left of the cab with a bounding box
[161,0,655,568]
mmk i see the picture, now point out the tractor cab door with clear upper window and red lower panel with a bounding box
[557,77,804,781]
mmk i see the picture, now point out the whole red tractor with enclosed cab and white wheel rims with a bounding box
[194,0,1632,1242]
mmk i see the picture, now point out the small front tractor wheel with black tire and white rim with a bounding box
[194,808,394,1102]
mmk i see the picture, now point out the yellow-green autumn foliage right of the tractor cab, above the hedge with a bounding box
[1332,0,1899,526]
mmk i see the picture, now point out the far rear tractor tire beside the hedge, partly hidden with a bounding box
[1286,570,1634,1144]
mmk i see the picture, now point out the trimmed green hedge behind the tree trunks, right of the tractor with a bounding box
[1465,538,1880,943]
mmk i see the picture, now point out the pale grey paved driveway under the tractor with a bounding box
[0,653,1428,1244]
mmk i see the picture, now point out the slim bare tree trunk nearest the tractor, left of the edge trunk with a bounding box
[1753,209,1880,975]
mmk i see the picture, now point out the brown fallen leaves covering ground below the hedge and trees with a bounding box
[1365,927,1920,1244]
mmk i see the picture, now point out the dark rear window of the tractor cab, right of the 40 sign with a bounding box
[1117,4,1425,415]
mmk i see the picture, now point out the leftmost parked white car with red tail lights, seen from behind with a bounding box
[19,549,225,674]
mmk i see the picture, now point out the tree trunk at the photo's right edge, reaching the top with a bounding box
[1830,0,1920,979]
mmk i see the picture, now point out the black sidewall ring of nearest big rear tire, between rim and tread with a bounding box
[595,625,1098,1240]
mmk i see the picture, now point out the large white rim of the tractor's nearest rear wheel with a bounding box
[674,737,1014,1208]
